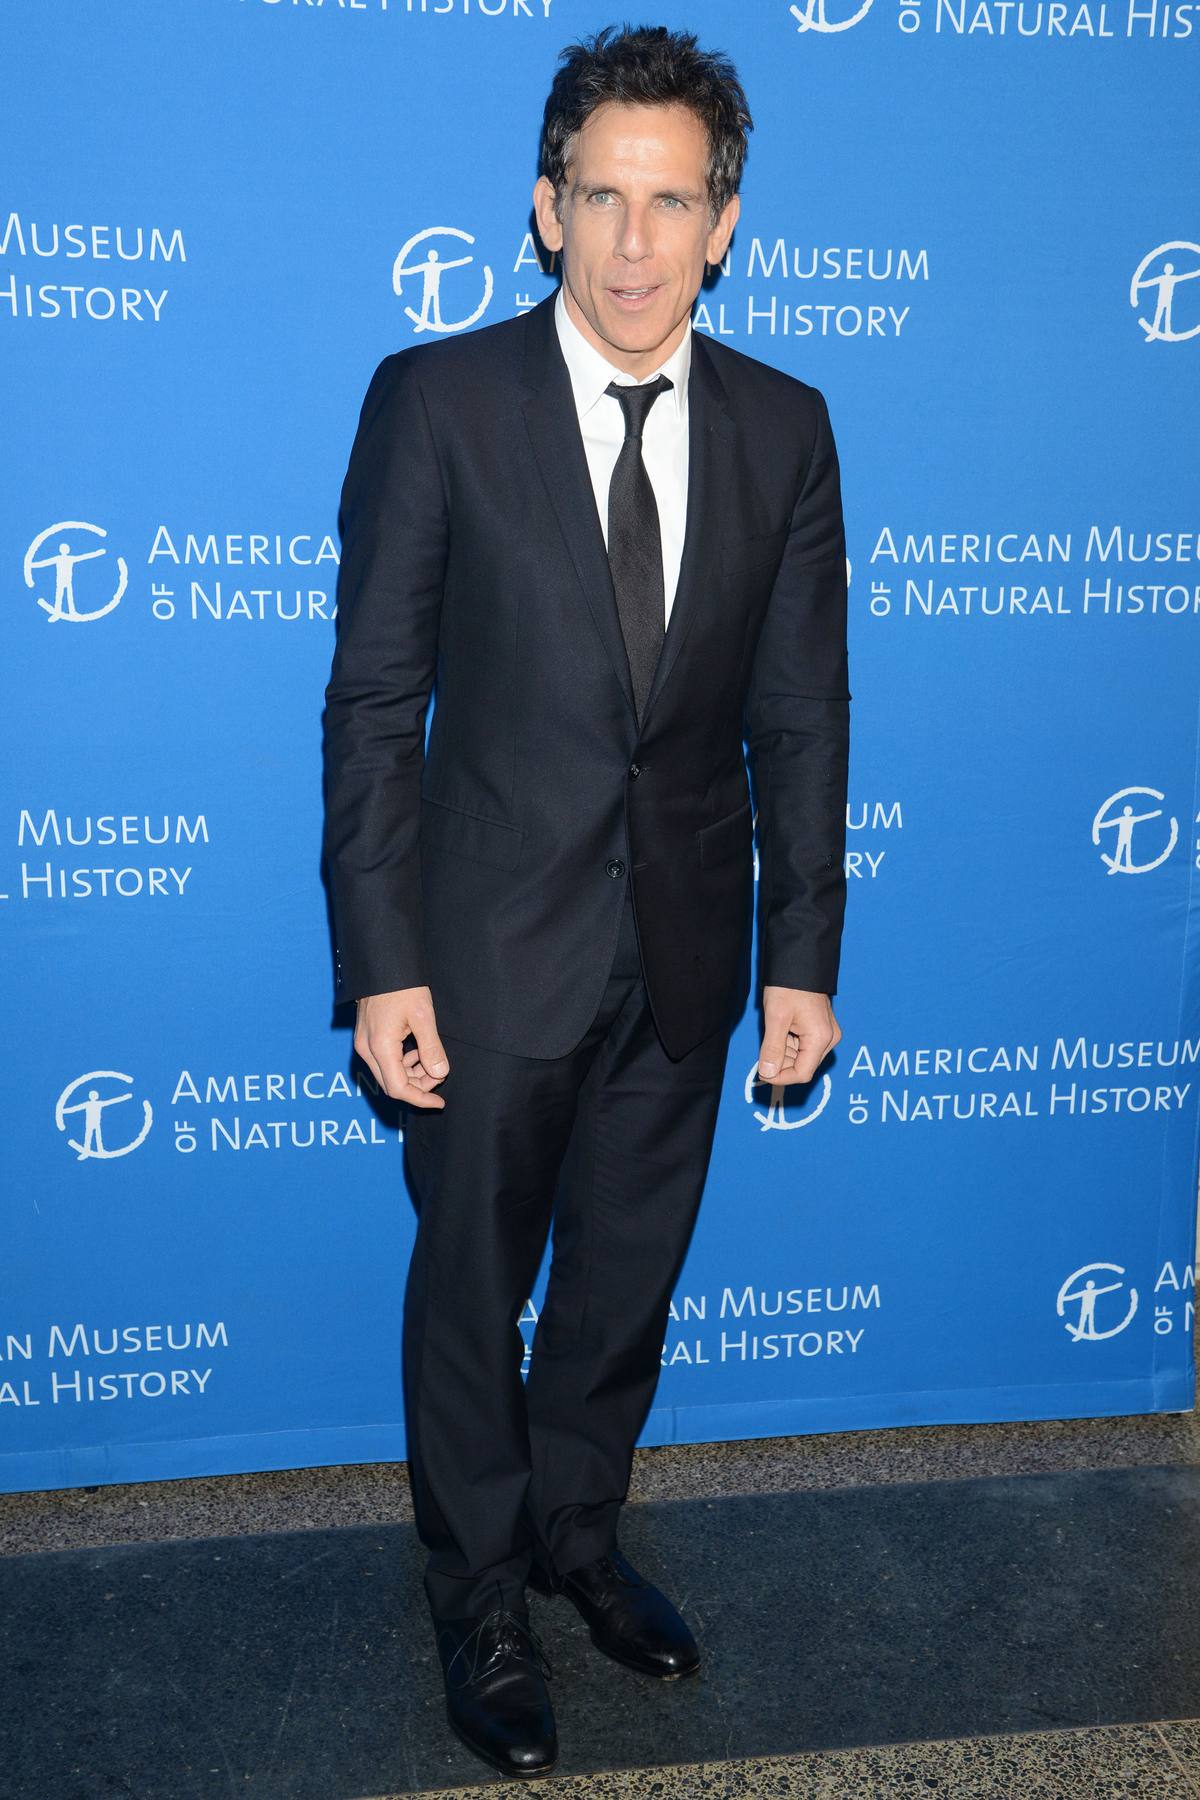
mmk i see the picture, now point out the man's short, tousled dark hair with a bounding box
[538,25,754,221]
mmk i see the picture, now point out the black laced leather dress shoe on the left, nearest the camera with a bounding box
[437,1606,558,1780]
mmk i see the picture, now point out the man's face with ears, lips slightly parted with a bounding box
[533,101,739,376]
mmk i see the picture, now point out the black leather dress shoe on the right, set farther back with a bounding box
[529,1550,700,1681]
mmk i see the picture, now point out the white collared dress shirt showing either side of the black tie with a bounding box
[554,286,691,628]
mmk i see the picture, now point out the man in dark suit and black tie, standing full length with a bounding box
[326,27,849,1775]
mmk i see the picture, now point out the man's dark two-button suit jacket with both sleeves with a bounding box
[324,297,851,1057]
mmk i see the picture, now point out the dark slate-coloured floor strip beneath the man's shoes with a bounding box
[0,1467,1200,1800]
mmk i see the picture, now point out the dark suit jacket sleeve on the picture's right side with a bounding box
[747,389,851,994]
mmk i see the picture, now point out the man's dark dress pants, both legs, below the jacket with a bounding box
[403,878,732,1620]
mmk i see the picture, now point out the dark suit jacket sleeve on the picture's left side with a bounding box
[324,351,448,1003]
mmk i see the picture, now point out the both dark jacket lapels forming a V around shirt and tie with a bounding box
[524,295,736,727]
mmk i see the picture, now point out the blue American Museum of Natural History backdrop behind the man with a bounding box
[0,0,1200,1490]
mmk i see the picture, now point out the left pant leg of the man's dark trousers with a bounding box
[403,904,637,1618]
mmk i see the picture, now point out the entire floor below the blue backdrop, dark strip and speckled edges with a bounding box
[0,1303,1200,1800]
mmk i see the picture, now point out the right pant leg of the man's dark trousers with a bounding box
[525,896,729,1575]
